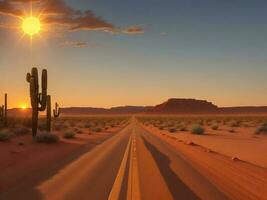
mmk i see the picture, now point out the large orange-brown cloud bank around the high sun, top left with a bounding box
[0,0,144,35]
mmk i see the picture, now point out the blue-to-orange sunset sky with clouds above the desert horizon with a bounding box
[0,0,267,107]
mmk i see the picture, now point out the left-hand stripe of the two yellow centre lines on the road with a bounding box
[108,135,132,200]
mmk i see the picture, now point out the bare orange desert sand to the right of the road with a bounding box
[139,117,267,199]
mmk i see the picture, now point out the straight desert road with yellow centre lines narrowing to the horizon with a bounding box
[0,119,230,200]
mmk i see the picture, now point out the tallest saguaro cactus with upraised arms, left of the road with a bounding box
[26,67,47,137]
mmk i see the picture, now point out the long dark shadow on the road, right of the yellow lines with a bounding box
[142,136,199,200]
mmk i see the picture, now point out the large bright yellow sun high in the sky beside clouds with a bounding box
[22,16,41,36]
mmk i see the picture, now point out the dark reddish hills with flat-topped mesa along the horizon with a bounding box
[8,98,267,116]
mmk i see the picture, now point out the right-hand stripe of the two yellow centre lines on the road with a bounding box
[127,126,141,200]
